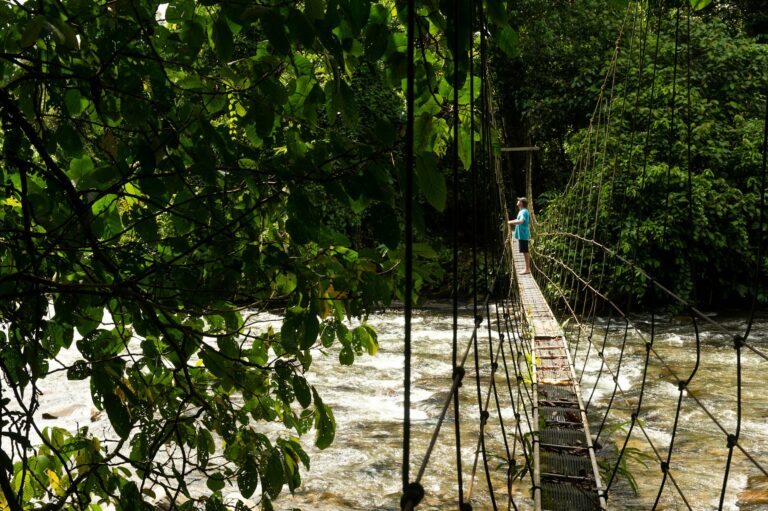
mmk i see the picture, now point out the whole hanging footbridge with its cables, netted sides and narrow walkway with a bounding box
[400,4,768,511]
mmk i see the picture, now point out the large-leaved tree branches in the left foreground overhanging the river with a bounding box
[0,0,516,511]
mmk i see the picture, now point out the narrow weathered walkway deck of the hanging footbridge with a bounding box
[512,242,607,511]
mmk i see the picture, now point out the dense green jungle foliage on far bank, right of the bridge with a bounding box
[500,2,768,306]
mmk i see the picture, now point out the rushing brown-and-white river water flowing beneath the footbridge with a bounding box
[10,308,768,511]
